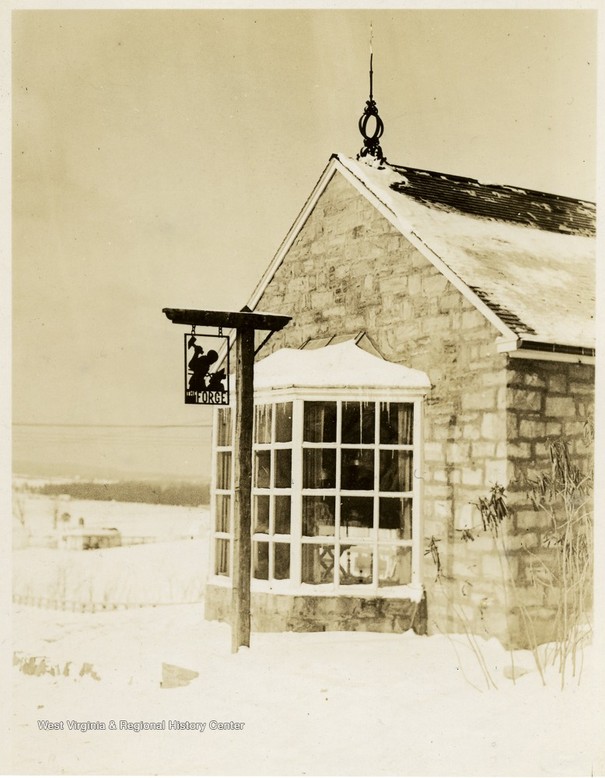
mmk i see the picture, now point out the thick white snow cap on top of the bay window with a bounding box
[254,340,431,390]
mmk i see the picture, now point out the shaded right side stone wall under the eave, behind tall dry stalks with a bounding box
[507,359,594,644]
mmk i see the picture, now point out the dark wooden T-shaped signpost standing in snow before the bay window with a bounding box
[162,308,291,653]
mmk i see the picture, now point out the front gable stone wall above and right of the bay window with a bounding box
[257,174,507,631]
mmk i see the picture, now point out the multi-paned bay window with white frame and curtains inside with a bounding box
[212,389,422,594]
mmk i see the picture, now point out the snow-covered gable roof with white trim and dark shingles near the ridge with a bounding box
[250,155,595,354]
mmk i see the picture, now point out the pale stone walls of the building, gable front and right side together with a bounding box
[243,168,594,645]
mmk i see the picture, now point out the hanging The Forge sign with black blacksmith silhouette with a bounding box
[185,328,229,405]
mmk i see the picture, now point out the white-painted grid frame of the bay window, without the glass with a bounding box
[209,387,425,597]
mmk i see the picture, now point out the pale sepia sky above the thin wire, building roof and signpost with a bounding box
[7,9,596,472]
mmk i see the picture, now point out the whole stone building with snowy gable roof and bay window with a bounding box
[206,115,595,645]
